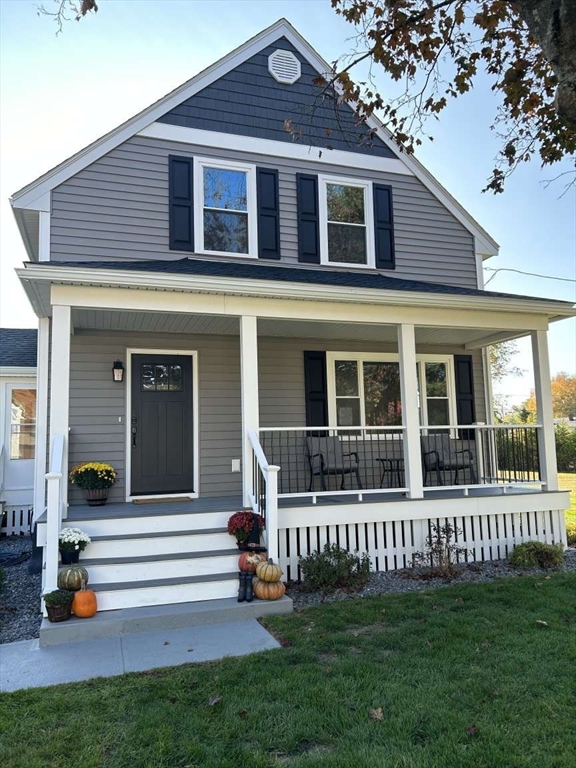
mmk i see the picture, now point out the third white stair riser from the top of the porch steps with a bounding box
[82,548,238,585]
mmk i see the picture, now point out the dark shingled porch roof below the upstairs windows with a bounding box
[50,258,569,305]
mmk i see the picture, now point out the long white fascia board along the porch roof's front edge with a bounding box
[16,264,576,317]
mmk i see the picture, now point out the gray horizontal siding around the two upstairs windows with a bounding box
[51,136,477,288]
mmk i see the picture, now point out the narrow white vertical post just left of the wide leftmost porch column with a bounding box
[33,317,50,520]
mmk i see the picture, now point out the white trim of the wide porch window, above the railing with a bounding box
[326,352,457,429]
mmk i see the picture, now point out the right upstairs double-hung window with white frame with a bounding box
[319,176,374,267]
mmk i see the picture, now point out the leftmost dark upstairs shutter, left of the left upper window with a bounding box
[168,155,194,251]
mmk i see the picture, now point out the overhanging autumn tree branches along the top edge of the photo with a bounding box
[39,0,576,192]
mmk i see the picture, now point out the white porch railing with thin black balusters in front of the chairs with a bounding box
[258,424,545,503]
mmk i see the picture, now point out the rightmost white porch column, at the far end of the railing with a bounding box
[532,331,558,491]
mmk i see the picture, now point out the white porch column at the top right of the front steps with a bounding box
[240,315,260,507]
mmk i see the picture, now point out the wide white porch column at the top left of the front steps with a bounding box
[50,305,72,516]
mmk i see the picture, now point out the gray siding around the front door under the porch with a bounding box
[69,331,242,504]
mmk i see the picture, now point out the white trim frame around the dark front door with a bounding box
[124,347,200,502]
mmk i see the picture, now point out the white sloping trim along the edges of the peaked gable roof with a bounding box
[11,19,498,256]
